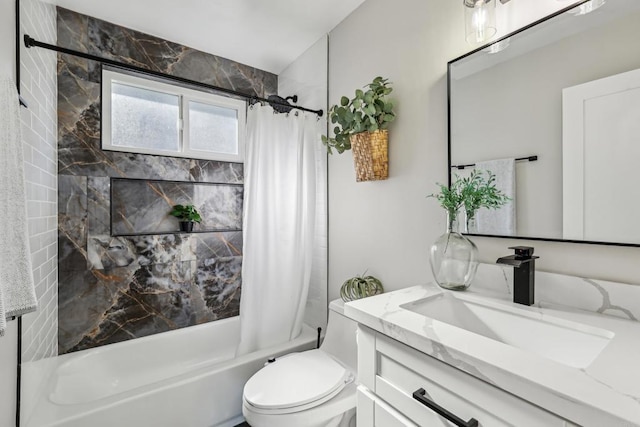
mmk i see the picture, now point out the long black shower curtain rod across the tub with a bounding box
[24,34,324,117]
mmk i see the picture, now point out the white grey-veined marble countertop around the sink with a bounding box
[345,284,640,427]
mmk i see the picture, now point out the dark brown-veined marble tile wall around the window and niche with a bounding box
[57,8,277,354]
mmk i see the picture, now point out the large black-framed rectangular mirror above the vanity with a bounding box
[448,0,640,246]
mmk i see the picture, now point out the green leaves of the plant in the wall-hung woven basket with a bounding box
[322,77,396,154]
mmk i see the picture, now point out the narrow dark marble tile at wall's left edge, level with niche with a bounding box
[58,175,87,270]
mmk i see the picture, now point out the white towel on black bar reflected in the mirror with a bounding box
[476,159,516,236]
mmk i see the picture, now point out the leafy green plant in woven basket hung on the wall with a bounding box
[322,77,396,182]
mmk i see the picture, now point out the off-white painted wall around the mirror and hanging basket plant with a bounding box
[329,0,640,298]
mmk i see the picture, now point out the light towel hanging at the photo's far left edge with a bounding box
[0,76,37,336]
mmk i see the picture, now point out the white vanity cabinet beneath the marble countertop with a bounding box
[358,325,573,427]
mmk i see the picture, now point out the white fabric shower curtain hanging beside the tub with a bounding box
[237,105,326,355]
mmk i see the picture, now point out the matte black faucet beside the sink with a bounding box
[496,246,539,305]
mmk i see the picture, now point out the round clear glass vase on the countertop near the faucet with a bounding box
[429,212,478,291]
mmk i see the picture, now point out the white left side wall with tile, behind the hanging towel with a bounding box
[0,0,58,427]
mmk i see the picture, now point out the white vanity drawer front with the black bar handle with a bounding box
[363,333,565,427]
